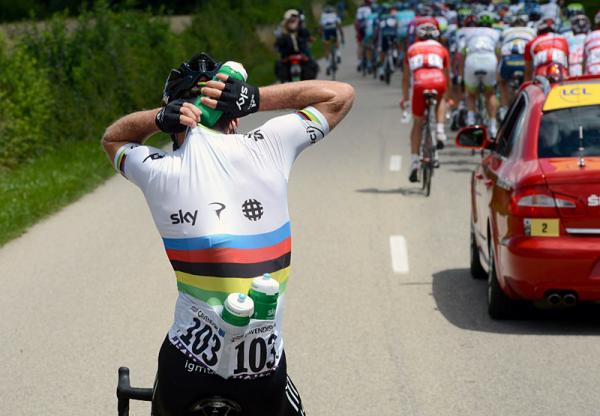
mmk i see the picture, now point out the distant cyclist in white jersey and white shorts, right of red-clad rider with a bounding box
[462,11,500,136]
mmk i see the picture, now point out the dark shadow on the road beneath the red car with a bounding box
[433,269,600,335]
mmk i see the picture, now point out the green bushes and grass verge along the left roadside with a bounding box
[0,0,346,245]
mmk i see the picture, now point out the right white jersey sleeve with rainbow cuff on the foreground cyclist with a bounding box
[247,107,329,176]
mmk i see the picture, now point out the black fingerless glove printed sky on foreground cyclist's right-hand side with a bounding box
[217,77,260,117]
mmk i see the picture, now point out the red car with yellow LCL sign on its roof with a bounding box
[456,72,600,319]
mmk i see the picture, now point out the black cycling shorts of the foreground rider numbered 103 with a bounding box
[152,338,305,416]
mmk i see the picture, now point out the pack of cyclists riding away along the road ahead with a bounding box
[277,0,600,177]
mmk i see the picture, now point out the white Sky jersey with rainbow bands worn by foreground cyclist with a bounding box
[114,107,329,378]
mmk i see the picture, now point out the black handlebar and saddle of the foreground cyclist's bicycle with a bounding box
[117,367,243,416]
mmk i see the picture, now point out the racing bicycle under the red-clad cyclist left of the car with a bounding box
[419,90,437,197]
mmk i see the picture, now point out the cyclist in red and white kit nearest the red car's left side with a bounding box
[400,22,450,182]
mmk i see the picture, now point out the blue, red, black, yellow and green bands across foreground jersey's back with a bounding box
[163,222,291,305]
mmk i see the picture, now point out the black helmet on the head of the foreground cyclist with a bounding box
[163,52,221,105]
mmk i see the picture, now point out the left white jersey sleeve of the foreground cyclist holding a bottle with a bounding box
[113,143,165,191]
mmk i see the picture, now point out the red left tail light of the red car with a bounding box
[509,186,577,218]
